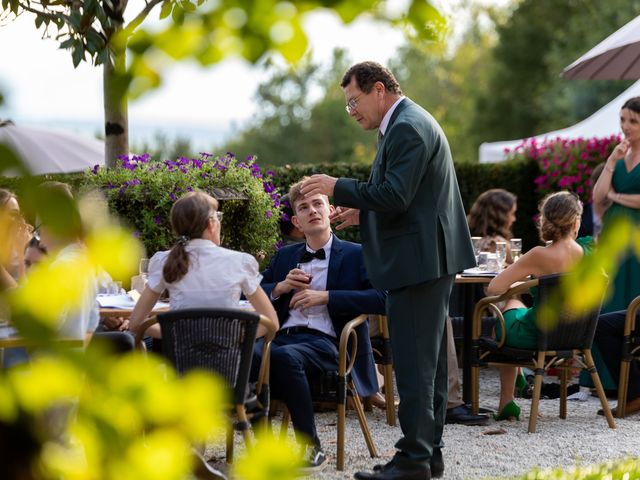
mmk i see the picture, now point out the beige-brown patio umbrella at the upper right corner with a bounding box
[562,16,640,80]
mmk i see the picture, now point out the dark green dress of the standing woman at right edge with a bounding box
[602,160,640,313]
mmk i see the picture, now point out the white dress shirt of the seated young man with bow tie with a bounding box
[283,234,338,338]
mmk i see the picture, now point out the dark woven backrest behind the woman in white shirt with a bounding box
[158,308,260,405]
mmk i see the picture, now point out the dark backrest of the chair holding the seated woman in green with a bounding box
[538,273,606,351]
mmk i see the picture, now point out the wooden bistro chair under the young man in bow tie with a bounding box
[280,315,378,471]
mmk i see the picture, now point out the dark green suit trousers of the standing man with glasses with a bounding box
[387,275,455,469]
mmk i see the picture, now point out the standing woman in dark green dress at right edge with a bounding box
[593,97,640,313]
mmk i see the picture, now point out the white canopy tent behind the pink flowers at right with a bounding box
[479,81,640,163]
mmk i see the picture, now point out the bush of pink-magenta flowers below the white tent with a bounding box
[506,135,621,203]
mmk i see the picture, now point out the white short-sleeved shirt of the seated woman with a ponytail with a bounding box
[147,238,262,310]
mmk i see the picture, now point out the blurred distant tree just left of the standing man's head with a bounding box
[225,50,375,165]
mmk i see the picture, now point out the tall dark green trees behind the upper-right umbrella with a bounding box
[473,0,640,143]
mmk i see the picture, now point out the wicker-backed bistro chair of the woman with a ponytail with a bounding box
[136,308,275,463]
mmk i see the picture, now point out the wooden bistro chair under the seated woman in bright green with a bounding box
[471,274,615,433]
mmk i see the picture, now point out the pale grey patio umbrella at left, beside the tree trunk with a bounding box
[0,122,104,175]
